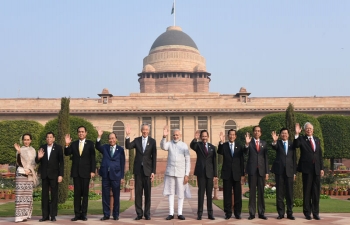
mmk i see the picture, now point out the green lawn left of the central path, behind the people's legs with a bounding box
[0,200,134,217]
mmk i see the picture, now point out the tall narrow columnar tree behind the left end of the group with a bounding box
[56,98,71,203]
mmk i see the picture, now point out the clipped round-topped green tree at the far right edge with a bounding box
[317,115,350,170]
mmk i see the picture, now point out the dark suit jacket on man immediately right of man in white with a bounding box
[190,139,218,178]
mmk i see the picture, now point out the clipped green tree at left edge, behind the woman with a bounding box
[0,120,44,165]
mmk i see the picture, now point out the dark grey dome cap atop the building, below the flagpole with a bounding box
[151,26,198,50]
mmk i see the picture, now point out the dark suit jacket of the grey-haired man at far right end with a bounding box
[294,136,323,175]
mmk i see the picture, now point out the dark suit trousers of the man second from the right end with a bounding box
[275,169,294,217]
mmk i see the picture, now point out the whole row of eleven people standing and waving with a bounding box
[14,120,324,222]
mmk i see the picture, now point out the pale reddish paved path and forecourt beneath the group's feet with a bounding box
[0,184,350,225]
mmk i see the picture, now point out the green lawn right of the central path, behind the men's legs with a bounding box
[213,198,350,213]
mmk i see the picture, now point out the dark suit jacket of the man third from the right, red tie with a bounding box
[244,138,269,176]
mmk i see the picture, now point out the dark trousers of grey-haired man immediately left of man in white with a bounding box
[135,166,151,217]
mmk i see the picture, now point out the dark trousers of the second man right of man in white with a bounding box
[223,177,242,216]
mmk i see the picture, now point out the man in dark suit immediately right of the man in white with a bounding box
[190,130,218,220]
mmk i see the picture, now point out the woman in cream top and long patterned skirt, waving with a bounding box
[14,133,38,222]
